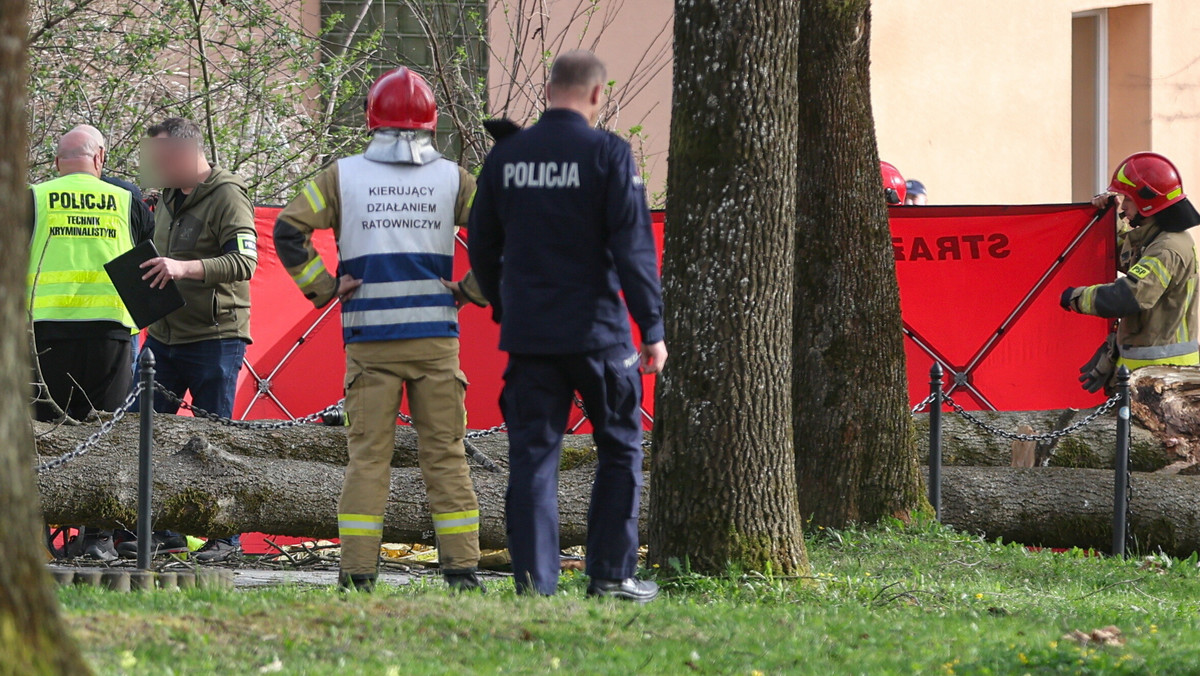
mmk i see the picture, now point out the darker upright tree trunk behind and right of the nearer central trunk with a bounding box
[792,0,925,526]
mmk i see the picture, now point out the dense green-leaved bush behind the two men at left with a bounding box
[29,0,377,202]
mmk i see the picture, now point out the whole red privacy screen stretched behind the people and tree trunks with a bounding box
[234,205,1115,432]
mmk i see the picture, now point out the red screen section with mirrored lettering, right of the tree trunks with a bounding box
[890,205,1116,411]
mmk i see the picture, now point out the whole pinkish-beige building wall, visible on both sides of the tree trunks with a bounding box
[477,0,1200,204]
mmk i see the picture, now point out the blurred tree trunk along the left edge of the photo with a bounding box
[0,0,91,674]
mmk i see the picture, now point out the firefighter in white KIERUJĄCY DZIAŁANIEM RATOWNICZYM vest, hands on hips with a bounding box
[275,68,486,591]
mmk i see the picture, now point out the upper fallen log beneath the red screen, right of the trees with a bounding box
[914,413,1166,472]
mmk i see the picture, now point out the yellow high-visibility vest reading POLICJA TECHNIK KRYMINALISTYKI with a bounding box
[25,174,136,333]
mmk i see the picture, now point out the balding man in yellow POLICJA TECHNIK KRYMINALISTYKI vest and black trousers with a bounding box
[26,128,151,420]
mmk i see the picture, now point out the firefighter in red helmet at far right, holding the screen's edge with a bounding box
[1061,152,1200,391]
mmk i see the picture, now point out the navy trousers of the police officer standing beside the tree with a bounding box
[500,345,643,596]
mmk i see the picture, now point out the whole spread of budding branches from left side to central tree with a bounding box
[29,0,670,203]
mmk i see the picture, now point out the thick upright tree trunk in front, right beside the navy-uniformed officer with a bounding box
[649,0,808,574]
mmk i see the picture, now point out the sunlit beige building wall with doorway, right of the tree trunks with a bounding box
[871,0,1200,204]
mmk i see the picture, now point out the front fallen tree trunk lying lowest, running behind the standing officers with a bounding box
[28,417,1200,556]
